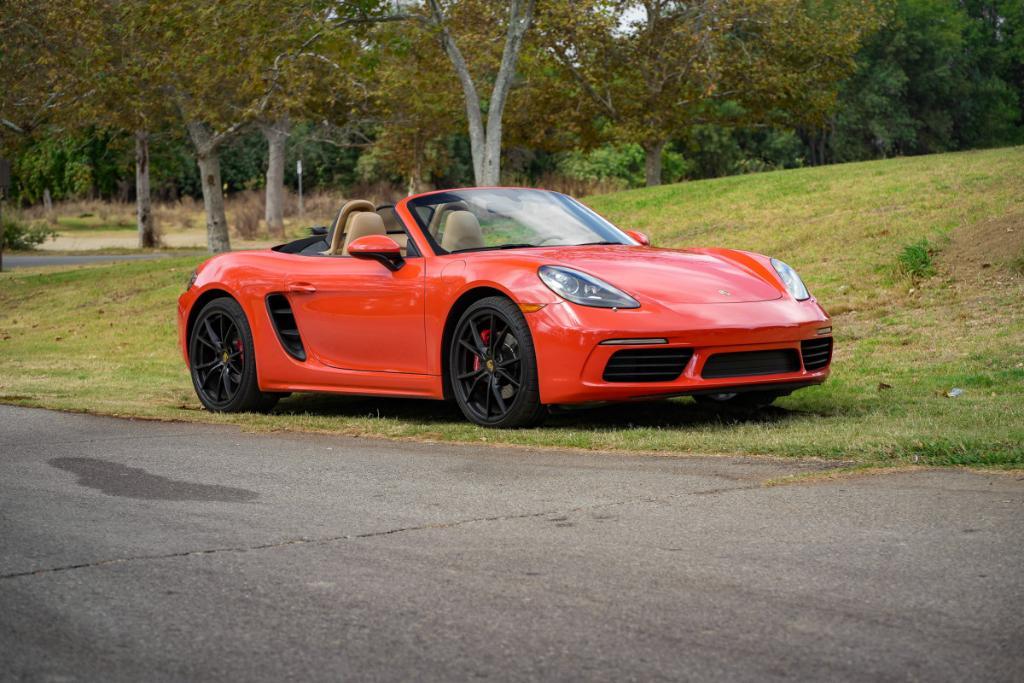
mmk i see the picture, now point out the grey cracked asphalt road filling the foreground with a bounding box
[0,407,1024,681]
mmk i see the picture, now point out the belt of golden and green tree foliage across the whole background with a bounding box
[0,0,1024,204]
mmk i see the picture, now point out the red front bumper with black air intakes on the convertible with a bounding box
[526,299,831,403]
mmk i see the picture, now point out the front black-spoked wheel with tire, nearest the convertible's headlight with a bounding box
[449,297,546,428]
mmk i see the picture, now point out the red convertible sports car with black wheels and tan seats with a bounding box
[178,187,833,427]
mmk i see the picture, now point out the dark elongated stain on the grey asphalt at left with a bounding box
[49,458,259,503]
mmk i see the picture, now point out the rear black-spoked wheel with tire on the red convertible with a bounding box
[188,297,280,413]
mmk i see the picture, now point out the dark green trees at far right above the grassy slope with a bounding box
[819,0,1024,163]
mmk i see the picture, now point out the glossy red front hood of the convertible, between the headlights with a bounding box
[520,246,782,306]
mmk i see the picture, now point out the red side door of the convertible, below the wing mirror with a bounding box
[286,256,427,375]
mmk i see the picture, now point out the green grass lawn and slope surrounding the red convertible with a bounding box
[0,147,1024,467]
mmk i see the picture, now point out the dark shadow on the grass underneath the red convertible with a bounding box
[274,393,825,430]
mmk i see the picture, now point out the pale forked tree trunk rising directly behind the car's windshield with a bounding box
[427,0,536,185]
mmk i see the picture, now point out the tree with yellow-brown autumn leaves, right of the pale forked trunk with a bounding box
[542,0,874,185]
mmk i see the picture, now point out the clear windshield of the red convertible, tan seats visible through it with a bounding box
[409,189,636,253]
